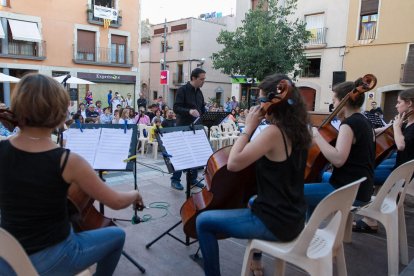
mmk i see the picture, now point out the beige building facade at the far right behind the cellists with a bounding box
[344,0,414,121]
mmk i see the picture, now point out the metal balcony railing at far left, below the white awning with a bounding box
[1,40,46,58]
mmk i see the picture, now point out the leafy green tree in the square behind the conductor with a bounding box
[212,0,310,80]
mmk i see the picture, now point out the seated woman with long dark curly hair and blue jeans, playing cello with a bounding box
[196,74,311,275]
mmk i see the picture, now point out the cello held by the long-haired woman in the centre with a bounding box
[180,80,291,239]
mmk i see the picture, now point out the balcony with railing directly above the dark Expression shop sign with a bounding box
[72,45,134,67]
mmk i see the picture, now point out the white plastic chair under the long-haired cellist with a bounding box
[241,177,366,276]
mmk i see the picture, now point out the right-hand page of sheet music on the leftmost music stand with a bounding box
[93,128,132,170]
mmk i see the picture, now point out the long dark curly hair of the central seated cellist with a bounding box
[259,74,312,149]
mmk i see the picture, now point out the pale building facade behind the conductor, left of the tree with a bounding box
[141,16,235,107]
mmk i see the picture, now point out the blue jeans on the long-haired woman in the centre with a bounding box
[196,208,278,276]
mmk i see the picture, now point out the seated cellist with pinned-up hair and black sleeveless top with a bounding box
[305,82,375,218]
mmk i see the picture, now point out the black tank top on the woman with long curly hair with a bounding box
[252,134,308,241]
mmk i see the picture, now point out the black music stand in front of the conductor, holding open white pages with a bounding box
[145,125,213,249]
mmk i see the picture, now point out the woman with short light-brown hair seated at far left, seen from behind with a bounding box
[0,74,142,275]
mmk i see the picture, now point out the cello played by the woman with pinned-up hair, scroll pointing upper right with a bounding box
[305,74,377,183]
